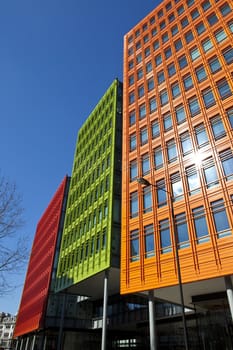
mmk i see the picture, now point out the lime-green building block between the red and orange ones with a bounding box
[56,79,122,295]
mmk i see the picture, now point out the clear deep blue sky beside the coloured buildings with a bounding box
[0,0,158,313]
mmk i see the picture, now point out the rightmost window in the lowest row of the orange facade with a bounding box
[211,199,231,238]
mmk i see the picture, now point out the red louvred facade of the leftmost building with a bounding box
[14,177,68,337]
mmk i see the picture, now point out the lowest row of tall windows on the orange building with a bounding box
[130,199,231,262]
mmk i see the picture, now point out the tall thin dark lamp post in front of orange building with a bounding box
[137,177,189,350]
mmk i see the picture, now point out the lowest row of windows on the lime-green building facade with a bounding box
[58,228,107,276]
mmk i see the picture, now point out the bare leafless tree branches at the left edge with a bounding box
[0,175,28,296]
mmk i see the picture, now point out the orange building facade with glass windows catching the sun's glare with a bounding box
[121,0,233,303]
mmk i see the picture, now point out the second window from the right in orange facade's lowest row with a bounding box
[192,206,210,243]
